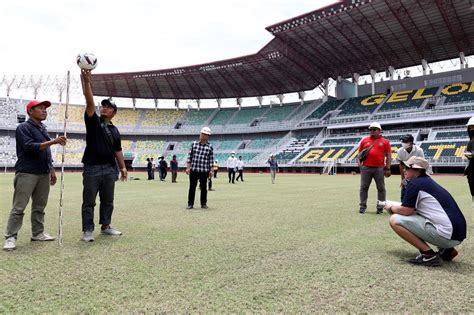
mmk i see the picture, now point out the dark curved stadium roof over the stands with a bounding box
[92,0,474,99]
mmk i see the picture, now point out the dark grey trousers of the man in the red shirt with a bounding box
[359,166,386,210]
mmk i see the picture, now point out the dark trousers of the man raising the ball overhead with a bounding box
[82,165,116,232]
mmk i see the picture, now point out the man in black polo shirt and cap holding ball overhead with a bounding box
[82,70,127,242]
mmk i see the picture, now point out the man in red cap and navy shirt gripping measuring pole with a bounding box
[3,100,66,250]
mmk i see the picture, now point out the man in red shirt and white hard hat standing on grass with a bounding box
[357,122,392,214]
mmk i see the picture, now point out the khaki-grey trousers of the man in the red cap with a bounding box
[5,173,51,238]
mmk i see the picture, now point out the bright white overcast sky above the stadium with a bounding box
[0,0,470,107]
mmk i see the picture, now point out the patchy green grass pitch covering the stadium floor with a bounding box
[0,174,474,313]
